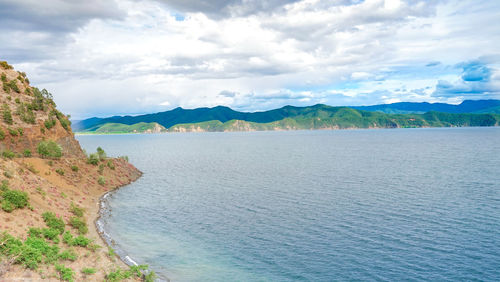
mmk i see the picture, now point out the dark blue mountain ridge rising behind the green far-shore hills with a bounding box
[73,100,500,133]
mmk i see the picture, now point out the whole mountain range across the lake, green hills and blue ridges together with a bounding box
[73,100,500,133]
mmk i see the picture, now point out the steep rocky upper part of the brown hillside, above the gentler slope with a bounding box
[0,62,84,157]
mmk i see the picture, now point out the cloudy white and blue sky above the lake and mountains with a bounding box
[0,0,500,119]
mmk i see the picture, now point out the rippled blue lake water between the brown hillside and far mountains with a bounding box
[77,128,500,281]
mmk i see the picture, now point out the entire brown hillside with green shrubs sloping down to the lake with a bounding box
[0,62,149,281]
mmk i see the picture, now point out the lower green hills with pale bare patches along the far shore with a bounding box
[82,105,500,133]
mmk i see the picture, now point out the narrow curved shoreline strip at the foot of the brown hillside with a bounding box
[93,171,170,282]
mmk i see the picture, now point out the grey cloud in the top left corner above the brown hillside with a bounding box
[0,0,125,62]
